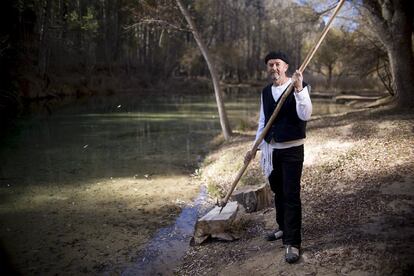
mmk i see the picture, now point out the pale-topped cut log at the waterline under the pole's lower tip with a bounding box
[193,202,238,245]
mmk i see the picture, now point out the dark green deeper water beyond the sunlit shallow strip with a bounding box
[0,93,348,188]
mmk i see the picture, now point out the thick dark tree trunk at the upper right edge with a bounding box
[363,0,414,108]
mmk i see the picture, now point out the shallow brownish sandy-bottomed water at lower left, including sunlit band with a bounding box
[0,175,198,275]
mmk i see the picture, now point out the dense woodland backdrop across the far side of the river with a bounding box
[0,0,413,128]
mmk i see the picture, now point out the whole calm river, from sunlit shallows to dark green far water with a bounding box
[0,90,356,275]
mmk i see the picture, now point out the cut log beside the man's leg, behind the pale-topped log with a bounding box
[231,184,273,213]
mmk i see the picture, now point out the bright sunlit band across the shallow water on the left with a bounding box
[5,175,197,211]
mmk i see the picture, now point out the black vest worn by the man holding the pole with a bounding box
[262,82,307,143]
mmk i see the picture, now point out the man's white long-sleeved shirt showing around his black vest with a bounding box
[256,78,312,149]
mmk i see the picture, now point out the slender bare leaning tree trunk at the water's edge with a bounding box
[176,0,232,140]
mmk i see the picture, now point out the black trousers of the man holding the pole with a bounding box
[269,145,304,246]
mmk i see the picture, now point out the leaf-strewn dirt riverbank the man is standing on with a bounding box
[177,106,414,275]
